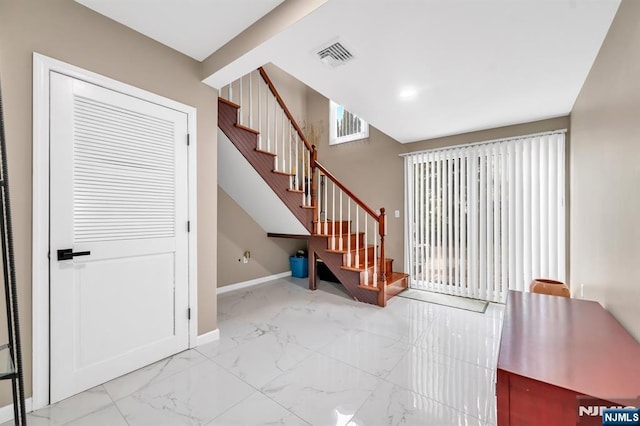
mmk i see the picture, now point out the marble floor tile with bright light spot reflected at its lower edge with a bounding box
[261,354,379,425]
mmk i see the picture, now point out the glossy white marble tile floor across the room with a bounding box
[12,278,503,426]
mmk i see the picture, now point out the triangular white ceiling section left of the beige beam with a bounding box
[76,0,284,61]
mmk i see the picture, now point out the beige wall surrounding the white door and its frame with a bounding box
[0,0,217,406]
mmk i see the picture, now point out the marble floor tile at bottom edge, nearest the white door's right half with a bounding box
[116,361,255,426]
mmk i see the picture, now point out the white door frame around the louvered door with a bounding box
[31,53,198,410]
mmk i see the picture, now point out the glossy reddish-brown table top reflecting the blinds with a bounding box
[498,290,640,402]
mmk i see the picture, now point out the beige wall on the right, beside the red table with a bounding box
[570,0,640,341]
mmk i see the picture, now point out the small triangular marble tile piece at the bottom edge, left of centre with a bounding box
[208,392,309,426]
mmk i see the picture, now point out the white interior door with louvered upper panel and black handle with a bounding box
[50,73,189,403]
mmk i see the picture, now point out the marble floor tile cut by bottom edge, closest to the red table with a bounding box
[349,381,483,426]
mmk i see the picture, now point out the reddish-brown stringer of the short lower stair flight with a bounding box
[309,235,379,305]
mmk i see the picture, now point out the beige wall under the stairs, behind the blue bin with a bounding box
[218,187,307,287]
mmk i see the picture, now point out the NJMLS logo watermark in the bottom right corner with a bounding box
[578,396,640,426]
